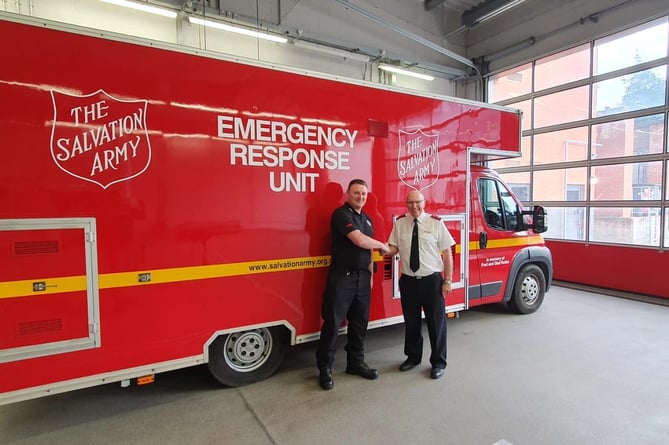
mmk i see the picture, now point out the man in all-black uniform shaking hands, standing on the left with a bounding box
[316,179,389,389]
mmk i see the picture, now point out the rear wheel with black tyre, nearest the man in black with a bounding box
[209,326,287,386]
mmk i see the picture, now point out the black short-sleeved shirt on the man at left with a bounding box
[330,202,374,270]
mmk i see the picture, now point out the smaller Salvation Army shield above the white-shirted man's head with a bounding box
[397,130,439,190]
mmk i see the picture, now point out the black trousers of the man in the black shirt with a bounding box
[316,267,372,369]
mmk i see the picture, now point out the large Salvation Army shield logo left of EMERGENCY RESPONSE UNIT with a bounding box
[51,90,151,189]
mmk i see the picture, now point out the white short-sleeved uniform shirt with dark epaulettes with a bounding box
[388,213,455,277]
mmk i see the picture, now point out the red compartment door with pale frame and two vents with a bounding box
[0,218,100,362]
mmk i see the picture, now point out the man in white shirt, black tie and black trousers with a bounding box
[388,190,455,379]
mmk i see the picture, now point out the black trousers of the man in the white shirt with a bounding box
[399,273,446,368]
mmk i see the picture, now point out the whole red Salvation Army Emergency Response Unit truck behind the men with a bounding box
[0,15,552,403]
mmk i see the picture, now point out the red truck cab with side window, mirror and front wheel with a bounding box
[467,166,553,314]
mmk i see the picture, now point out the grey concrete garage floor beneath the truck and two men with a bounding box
[0,286,669,445]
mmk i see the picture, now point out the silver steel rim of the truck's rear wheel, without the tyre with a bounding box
[225,328,272,372]
